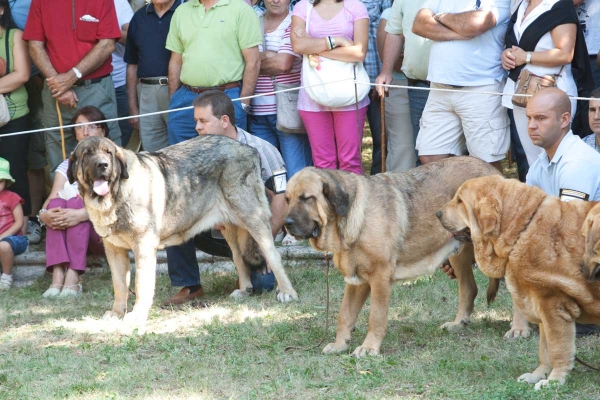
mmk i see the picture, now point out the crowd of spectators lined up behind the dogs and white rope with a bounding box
[0,0,600,304]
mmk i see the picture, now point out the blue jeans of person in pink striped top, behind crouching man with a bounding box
[248,114,312,180]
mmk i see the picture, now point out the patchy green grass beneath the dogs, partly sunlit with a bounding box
[0,263,600,399]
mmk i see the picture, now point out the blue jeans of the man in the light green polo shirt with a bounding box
[167,86,247,144]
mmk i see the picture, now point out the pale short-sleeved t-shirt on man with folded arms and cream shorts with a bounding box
[421,0,510,86]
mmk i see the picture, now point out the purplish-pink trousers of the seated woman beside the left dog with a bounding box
[46,197,104,273]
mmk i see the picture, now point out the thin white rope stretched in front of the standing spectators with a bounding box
[2,78,598,137]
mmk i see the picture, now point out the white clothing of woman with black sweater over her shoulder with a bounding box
[502,0,580,109]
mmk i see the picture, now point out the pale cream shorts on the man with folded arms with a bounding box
[417,82,510,162]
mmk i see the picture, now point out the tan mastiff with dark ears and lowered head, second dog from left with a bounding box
[284,157,499,357]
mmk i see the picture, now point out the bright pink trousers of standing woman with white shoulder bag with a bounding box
[300,107,367,174]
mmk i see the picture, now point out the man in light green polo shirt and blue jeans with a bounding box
[166,0,263,304]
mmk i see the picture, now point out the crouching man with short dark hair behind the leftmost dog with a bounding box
[163,90,287,306]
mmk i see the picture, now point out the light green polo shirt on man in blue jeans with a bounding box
[167,0,262,87]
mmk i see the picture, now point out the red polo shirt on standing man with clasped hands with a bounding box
[23,0,121,79]
